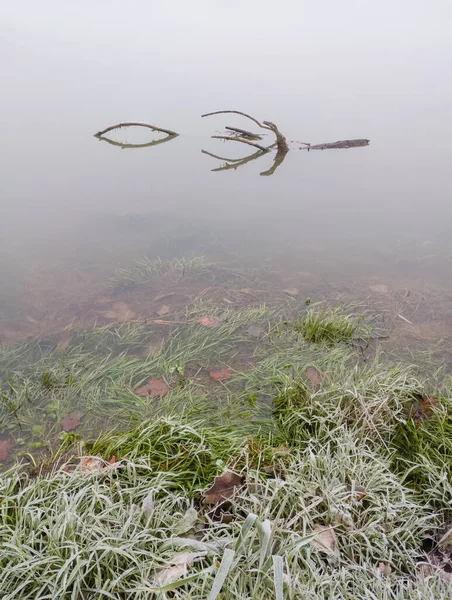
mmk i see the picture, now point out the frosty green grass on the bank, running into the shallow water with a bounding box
[0,300,452,600]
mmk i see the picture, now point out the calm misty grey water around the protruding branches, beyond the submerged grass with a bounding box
[0,0,452,341]
